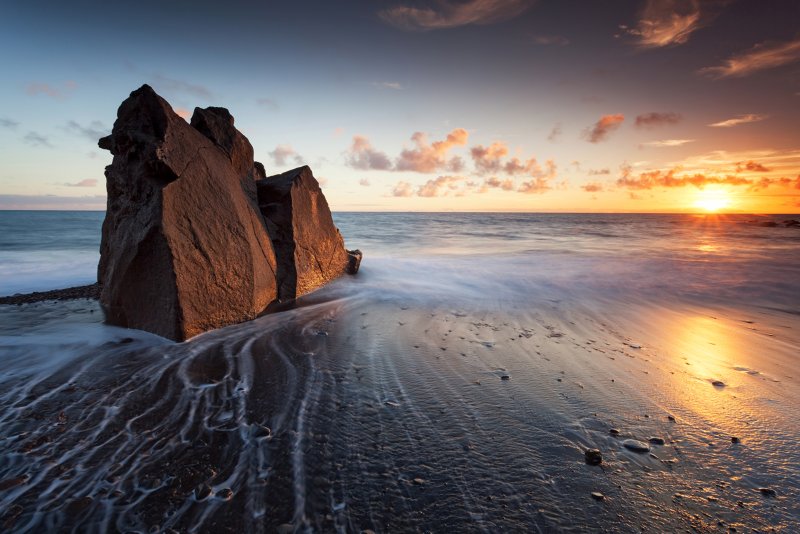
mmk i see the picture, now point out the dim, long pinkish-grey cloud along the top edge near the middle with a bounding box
[378,0,532,31]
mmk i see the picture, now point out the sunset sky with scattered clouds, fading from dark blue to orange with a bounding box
[0,0,800,214]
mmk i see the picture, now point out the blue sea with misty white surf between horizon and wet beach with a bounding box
[0,211,800,311]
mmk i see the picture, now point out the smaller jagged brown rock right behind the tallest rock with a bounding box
[257,166,354,300]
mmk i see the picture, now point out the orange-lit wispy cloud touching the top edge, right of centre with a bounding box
[620,0,701,48]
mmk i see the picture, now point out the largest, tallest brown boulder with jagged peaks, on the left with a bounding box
[98,85,277,340]
